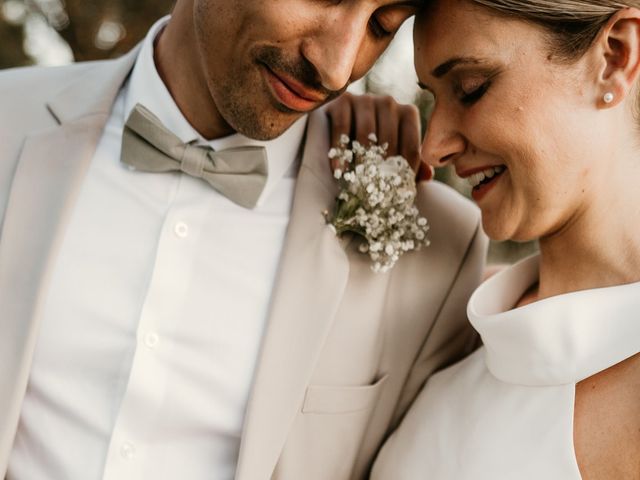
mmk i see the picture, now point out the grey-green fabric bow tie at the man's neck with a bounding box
[121,104,268,208]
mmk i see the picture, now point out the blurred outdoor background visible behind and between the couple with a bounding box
[0,0,537,263]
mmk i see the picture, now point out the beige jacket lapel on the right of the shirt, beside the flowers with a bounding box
[236,111,349,480]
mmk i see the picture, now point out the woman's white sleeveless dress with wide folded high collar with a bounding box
[372,256,640,480]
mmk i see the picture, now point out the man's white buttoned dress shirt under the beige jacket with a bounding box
[7,18,306,480]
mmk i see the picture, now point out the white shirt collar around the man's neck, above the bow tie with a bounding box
[124,16,307,206]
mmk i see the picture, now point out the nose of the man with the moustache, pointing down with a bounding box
[301,12,369,91]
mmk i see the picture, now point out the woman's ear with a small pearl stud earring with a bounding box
[596,8,640,106]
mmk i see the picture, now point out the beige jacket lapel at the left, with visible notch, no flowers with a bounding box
[0,50,137,473]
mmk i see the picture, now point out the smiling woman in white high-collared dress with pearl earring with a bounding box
[332,0,640,480]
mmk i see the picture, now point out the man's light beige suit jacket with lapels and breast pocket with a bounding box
[0,51,486,480]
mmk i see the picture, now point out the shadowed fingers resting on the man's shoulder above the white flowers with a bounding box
[327,92,433,181]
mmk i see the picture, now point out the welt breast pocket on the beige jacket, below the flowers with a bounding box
[302,375,388,414]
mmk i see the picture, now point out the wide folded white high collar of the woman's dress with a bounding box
[467,255,640,386]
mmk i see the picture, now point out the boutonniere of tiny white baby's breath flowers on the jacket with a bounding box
[325,134,429,272]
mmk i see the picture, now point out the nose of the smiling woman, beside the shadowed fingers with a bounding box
[422,105,467,167]
